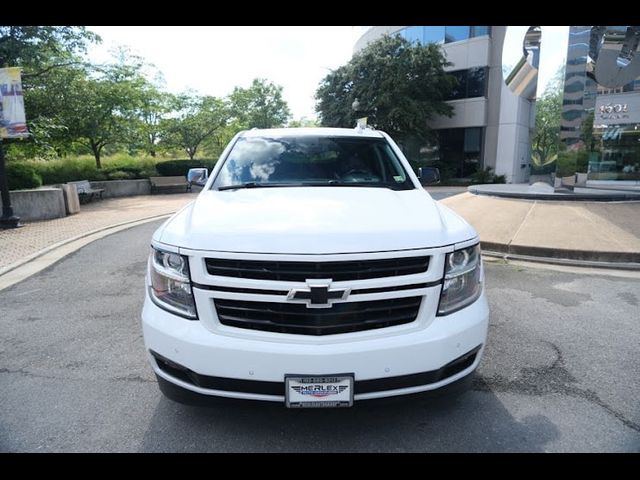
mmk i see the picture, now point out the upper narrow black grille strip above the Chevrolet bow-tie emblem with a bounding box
[205,257,429,282]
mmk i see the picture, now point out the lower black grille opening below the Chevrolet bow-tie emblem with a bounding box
[214,297,422,335]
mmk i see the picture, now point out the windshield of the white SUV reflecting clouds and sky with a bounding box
[212,136,414,190]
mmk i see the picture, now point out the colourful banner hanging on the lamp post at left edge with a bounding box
[0,67,29,138]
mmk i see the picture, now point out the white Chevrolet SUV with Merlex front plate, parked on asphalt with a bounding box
[142,128,489,407]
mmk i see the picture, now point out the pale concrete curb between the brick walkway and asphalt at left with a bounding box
[0,213,173,290]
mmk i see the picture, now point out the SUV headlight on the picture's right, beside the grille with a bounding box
[438,244,482,315]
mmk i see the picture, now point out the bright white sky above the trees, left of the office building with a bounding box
[87,26,354,119]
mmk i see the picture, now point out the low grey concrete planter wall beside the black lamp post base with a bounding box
[0,187,66,220]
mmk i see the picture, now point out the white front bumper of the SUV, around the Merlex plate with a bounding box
[142,292,489,402]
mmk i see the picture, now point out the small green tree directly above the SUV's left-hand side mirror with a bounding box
[163,93,230,160]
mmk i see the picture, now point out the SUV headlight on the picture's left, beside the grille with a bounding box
[149,247,198,319]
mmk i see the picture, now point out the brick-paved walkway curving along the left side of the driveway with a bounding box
[0,193,197,271]
